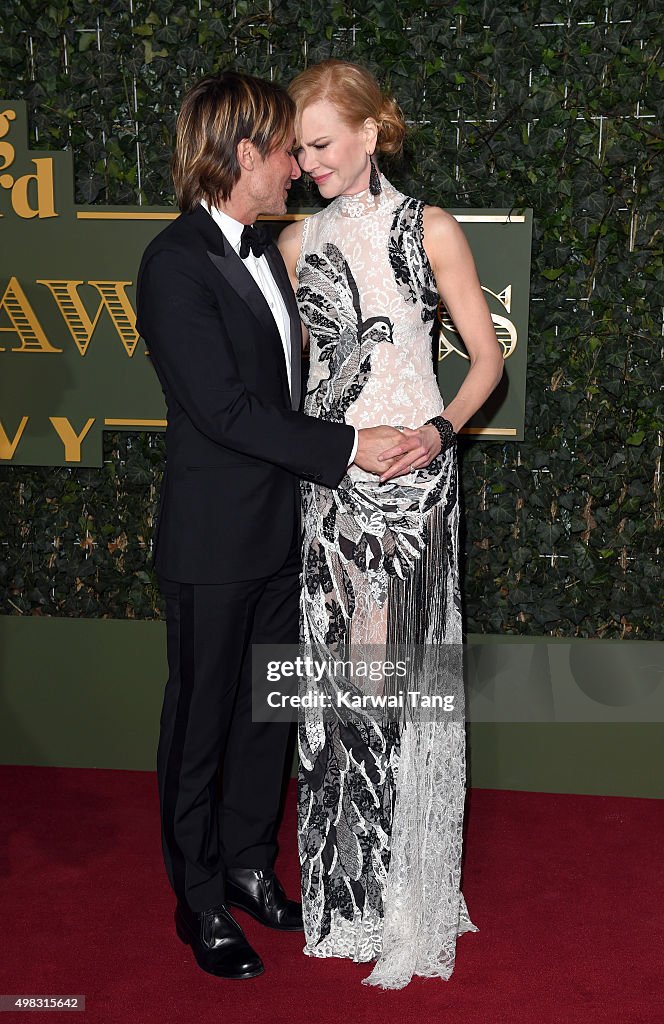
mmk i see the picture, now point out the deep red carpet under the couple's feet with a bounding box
[0,767,664,1024]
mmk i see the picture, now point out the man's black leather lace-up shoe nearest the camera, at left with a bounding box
[175,902,264,980]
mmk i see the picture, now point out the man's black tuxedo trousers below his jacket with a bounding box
[157,531,300,911]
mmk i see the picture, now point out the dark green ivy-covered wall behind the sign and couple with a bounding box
[0,0,664,639]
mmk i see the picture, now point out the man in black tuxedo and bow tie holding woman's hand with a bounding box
[137,72,422,978]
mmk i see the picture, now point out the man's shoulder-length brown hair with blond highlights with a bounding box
[171,71,295,212]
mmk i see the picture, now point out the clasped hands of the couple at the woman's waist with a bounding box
[354,423,441,483]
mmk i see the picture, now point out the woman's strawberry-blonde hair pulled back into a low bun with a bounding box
[288,59,406,155]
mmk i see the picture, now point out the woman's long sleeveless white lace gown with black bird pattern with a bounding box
[296,176,476,988]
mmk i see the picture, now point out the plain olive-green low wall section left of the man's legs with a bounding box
[0,616,166,769]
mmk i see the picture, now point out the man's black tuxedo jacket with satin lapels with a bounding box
[137,206,354,584]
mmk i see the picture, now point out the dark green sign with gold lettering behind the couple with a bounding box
[0,100,532,466]
